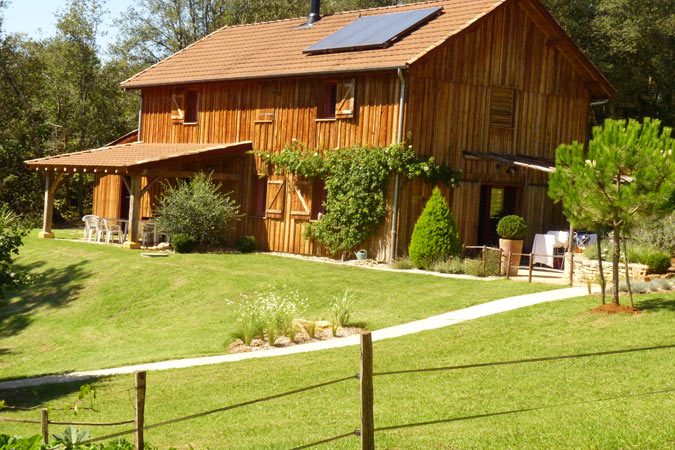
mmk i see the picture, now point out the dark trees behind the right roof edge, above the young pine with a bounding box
[544,0,675,126]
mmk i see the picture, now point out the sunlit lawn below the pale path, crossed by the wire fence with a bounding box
[0,294,675,450]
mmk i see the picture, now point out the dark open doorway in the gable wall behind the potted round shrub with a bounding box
[478,186,522,247]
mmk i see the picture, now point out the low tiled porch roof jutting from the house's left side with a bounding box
[25,141,253,174]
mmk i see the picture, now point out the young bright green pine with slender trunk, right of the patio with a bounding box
[549,118,675,305]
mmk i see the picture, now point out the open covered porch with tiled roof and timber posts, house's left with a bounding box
[25,141,255,249]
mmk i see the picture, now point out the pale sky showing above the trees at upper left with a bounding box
[3,0,134,50]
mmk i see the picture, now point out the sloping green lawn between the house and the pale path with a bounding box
[0,230,553,379]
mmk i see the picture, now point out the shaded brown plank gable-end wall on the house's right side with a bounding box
[399,2,590,251]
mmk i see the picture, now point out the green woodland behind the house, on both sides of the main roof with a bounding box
[0,0,675,223]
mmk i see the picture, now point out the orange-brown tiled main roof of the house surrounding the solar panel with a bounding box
[122,0,508,88]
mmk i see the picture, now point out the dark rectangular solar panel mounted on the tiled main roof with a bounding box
[303,7,443,54]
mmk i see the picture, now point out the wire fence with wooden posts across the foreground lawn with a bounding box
[0,333,675,450]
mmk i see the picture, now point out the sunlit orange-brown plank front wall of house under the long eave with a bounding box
[135,72,399,259]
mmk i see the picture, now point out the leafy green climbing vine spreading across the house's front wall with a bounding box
[253,142,461,255]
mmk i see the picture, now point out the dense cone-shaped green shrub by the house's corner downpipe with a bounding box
[408,187,462,269]
